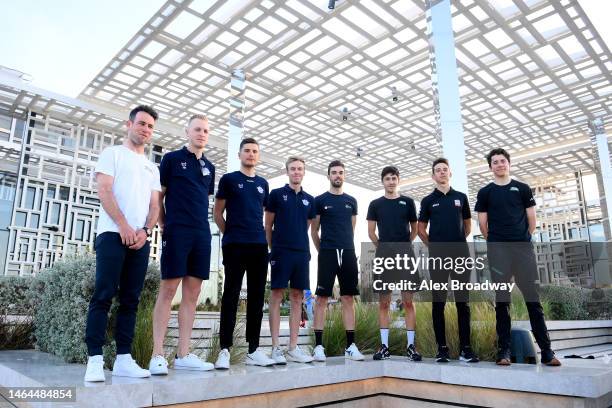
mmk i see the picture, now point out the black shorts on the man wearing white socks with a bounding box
[372,242,421,293]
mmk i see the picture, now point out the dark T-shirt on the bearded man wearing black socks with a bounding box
[315,191,357,249]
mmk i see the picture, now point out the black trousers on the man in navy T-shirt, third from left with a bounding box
[219,244,268,349]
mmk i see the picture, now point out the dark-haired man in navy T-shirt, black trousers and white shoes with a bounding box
[214,138,274,369]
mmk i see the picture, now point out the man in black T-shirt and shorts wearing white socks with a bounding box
[366,166,422,361]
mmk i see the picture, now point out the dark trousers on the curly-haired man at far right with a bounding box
[487,242,550,350]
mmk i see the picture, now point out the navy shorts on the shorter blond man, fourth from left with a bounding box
[270,248,310,290]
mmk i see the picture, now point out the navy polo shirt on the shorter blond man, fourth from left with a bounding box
[266,184,316,252]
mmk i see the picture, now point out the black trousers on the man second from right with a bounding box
[429,243,472,349]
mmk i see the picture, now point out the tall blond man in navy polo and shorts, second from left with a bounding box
[149,115,215,375]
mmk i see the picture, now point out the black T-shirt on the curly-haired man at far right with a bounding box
[474,180,535,242]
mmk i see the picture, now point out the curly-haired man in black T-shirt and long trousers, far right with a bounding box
[475,149,561,366]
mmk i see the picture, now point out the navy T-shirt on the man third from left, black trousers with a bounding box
[216,171,269,245]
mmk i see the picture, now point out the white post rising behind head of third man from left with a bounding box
[227,69,246,173]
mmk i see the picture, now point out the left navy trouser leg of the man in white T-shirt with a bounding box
[85,232,126,356]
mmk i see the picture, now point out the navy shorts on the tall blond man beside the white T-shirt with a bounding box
[161,226,211,279]
